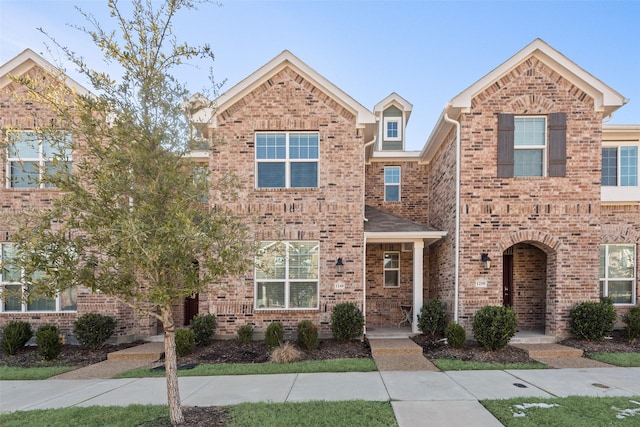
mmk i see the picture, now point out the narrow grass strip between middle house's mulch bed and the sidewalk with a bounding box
[115,358,377,378]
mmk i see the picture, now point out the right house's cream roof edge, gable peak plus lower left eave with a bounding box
[422,38,629,161]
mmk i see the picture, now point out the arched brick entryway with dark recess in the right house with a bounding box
[502,242,549,333]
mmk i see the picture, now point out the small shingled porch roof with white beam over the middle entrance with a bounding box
[364,206,447,245]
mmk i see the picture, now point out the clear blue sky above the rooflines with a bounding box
[0,0,640,149]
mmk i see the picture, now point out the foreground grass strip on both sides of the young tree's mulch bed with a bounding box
[0,400,398,427]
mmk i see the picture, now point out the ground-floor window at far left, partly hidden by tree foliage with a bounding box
[0,243,77,313]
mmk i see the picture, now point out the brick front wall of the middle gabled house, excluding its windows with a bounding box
[206,68,364,335]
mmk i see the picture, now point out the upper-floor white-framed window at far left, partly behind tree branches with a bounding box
[7,131,71,188]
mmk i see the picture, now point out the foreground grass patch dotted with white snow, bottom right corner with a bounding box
[480,396,640,427]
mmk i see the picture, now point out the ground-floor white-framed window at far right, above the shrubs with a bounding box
[600,244,636,305]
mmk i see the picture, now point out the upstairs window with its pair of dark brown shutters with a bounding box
[498,113,567,178]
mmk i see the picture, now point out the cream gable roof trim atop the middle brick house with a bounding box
[206,50,375,127]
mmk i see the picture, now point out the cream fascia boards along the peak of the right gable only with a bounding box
[451,39,628,115]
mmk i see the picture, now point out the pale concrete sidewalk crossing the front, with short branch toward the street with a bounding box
[0,368,640,427]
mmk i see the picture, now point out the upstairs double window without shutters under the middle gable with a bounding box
[256,132,319,188]
